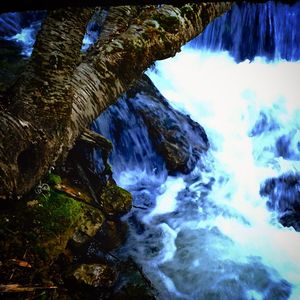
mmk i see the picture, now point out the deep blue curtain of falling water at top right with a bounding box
[190,1,300,62]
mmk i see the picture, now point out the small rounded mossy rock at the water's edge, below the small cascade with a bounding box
[100,183,132,217]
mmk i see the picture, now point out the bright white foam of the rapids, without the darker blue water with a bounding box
[141,47,300,299]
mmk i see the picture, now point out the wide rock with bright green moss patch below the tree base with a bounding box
[27,190,104,259]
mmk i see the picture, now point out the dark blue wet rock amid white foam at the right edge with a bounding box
[260,173,300,231]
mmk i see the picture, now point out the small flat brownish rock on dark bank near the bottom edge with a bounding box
[67,263,118,288]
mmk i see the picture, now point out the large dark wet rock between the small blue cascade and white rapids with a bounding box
[127,75,209,174]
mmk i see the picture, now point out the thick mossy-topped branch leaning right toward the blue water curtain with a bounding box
[69,2,231,147]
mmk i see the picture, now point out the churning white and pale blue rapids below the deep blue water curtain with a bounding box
[144,47,300,299]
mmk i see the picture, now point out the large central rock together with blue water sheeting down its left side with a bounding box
[93,75,209,175]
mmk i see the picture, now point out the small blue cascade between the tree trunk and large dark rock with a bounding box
[93,97,166,186]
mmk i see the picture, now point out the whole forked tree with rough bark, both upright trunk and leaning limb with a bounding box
[0,3,231,198]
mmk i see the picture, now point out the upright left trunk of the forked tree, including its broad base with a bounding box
[0,9,93,197]
